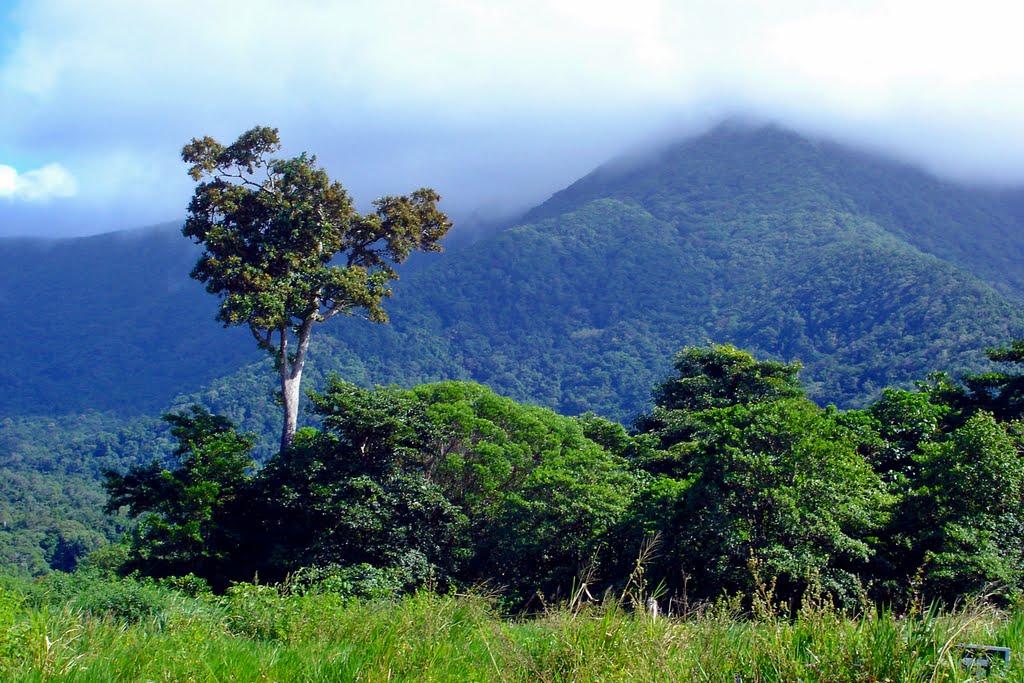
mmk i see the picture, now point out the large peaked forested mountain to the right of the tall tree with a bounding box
[299,125,1024,420]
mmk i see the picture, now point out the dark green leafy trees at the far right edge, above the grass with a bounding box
[867,358,1024,601]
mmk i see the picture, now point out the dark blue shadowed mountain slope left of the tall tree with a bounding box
[0,224,259,415]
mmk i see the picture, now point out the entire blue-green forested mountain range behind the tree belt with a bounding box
[0,125,1024,430]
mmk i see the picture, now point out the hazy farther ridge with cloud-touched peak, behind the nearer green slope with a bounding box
[524,123,1024,294]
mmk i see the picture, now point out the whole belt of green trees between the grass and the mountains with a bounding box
[90,342,1024,606]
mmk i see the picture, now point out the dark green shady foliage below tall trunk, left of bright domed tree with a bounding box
[260,436,466,589]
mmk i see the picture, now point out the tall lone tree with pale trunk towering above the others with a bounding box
[181,127,452,450]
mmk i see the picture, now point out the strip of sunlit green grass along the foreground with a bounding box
[0,580,1024,683]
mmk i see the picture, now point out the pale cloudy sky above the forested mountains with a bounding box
[0,0,1024,240]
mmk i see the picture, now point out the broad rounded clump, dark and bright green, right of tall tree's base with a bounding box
[261,380,636,600]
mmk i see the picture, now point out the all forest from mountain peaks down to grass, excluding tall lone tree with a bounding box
[0,125,1024,606]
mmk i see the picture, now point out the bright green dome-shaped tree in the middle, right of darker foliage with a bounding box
[414,382,636,600]
